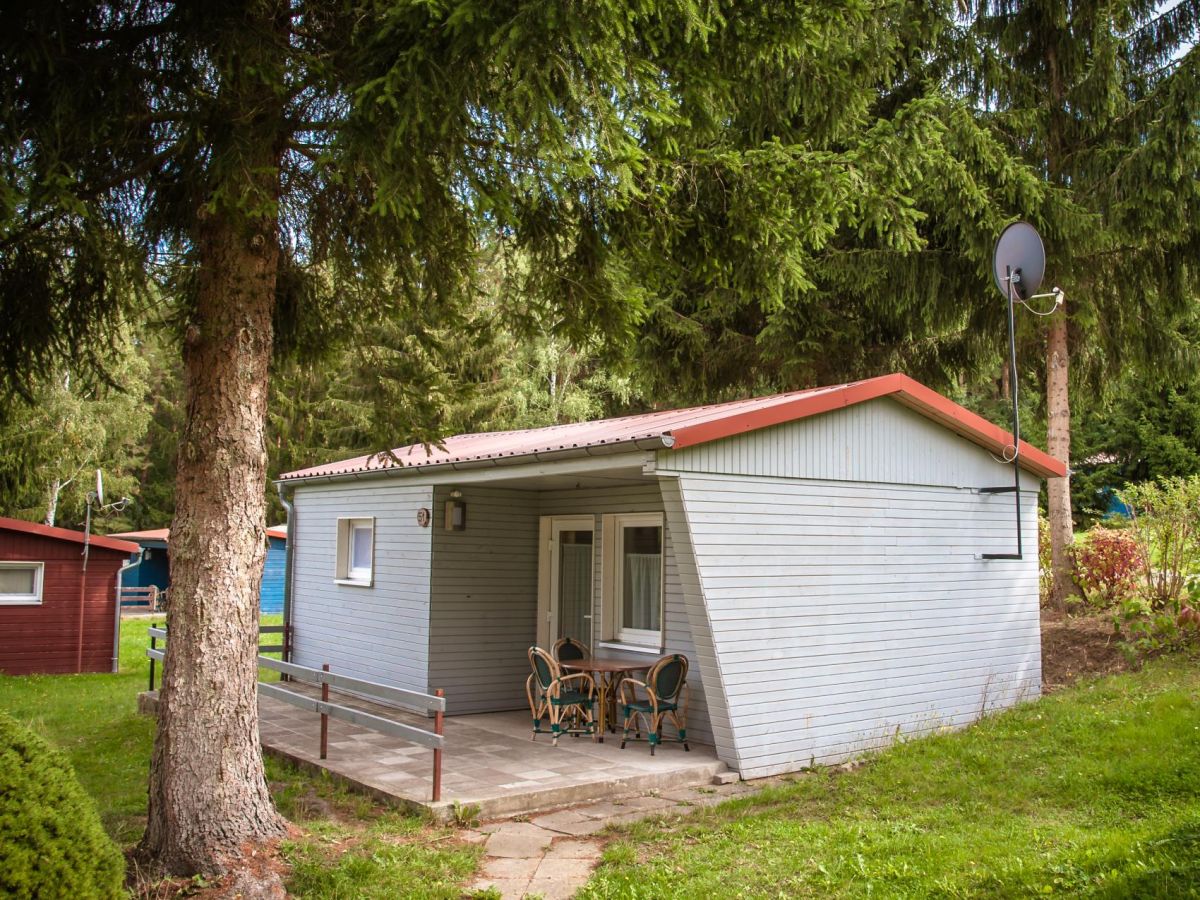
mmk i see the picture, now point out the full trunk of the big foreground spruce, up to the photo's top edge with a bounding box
[139,1,289,875]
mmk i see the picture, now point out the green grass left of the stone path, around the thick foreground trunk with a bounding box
[0,616,479,899]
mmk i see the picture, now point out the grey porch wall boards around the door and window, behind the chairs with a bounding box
[540,481,728,748]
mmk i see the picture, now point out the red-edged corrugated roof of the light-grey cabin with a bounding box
[280,374,1067,480]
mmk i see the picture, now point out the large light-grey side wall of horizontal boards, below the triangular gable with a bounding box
[678,475,1042,778]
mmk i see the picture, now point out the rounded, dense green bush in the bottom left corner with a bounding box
[0,712,125,900]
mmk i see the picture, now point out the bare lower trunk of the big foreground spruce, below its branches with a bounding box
[142,211,283,874]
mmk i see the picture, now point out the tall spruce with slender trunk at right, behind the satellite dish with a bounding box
[955,0,1200,606]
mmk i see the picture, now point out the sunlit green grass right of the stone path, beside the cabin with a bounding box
[580,656,1200,898]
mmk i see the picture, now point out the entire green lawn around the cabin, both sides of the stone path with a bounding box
[0,619,1200,898]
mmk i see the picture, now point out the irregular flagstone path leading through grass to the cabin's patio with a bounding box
[464,773,760,900]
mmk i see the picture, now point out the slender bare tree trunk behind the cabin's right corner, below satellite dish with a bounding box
[1046,308,1079,611]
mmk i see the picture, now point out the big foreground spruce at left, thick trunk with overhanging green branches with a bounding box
[0,0,1032,874]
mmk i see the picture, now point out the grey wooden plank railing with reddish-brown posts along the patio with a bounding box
[146,623,446,803]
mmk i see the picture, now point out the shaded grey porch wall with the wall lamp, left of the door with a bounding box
[430,485,538,714]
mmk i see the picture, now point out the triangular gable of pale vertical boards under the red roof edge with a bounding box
[656,397,1040,491]
